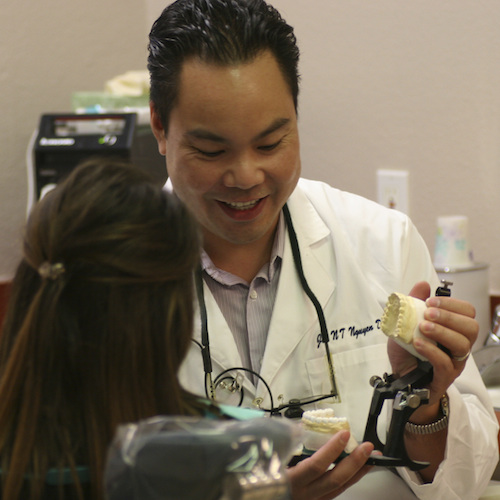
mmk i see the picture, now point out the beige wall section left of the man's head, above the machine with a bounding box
[0,0,149,280]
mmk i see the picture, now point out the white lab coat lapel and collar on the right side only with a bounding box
[258,190,336,392]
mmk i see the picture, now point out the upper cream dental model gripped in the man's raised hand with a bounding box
[380,293,427,361]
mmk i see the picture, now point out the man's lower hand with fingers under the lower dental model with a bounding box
[287,431,373,500]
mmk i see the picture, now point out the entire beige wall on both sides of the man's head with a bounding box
[0,0,500,294]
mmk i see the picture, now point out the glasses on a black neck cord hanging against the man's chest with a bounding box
[193,205,340,418]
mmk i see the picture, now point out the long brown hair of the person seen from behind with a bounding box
[0,160,199,500]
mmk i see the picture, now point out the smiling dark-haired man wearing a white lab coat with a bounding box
[148,0,498,500]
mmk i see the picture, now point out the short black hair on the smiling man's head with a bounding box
[148,0,299,133]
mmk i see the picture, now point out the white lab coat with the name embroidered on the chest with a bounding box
[180,179,498,500]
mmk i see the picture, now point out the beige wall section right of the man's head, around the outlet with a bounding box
[274,0,500,294]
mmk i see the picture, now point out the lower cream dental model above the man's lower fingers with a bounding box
[302,408,358,453]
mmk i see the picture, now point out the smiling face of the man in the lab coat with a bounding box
[152,52,300,253]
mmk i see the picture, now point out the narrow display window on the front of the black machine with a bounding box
[54,116,125,137]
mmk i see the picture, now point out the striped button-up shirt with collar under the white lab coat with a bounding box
[201,213,285,373]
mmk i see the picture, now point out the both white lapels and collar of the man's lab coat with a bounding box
[191,184,335,405]
